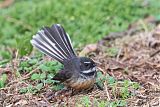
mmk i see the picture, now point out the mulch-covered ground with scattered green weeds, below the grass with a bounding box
[0,17,160,107]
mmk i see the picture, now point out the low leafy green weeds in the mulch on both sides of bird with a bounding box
[0,55,140,107]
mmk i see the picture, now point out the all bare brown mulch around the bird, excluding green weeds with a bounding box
[0,18,160,107]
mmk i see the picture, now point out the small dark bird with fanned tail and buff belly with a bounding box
[31,24,97,90]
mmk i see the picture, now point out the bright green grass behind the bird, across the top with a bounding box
[0,0,159,59]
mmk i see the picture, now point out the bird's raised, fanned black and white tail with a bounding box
[31,24,76,63]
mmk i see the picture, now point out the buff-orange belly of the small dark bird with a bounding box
[65,78,95,90]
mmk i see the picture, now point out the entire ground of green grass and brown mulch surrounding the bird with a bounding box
[0,0,160,107]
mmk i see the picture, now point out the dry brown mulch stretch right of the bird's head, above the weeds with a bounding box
[96,25,160,107]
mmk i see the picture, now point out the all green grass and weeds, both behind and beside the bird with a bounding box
[0,0,160,107]
